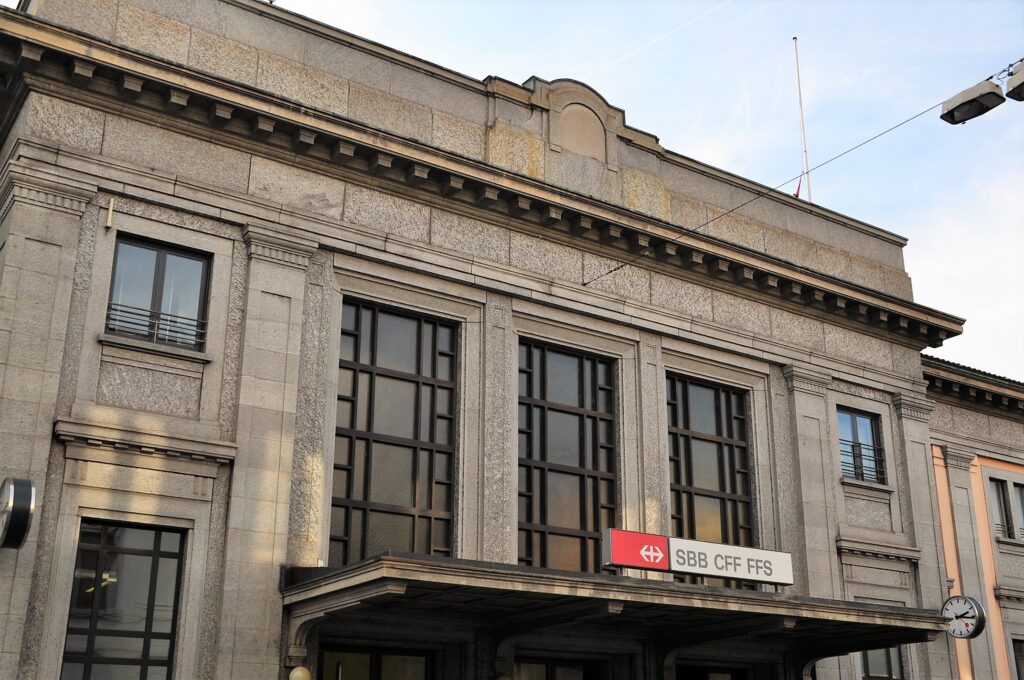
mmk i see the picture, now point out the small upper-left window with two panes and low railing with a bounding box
[105,238,210,349]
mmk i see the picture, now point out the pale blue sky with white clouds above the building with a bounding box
[2,0,1024,380]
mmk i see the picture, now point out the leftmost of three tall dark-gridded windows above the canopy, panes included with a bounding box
[329,300,458,565]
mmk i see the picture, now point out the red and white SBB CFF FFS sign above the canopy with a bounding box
[603,528,793,586]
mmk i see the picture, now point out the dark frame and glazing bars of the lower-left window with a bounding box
[58,517,188,680]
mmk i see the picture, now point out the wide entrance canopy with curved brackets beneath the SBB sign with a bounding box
[282,553,943,677]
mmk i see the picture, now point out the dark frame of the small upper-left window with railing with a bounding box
[103,232,213,351]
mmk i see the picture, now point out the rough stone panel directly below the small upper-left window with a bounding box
[96,360,203,419]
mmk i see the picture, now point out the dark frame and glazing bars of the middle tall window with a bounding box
[514,334,623,573]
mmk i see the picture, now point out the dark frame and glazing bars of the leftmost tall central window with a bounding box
[327,296,464,566]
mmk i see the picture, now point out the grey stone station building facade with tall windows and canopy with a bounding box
[0,0,1024,680]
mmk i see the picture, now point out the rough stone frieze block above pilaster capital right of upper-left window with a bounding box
[249,156,345,219]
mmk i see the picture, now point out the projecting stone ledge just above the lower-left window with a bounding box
[53,420,236,465]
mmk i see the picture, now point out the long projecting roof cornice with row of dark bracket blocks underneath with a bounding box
[0,22,964,349]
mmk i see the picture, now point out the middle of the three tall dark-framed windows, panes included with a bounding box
[518,341,617,571]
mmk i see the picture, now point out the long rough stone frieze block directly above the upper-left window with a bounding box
[103,116,249,192]
